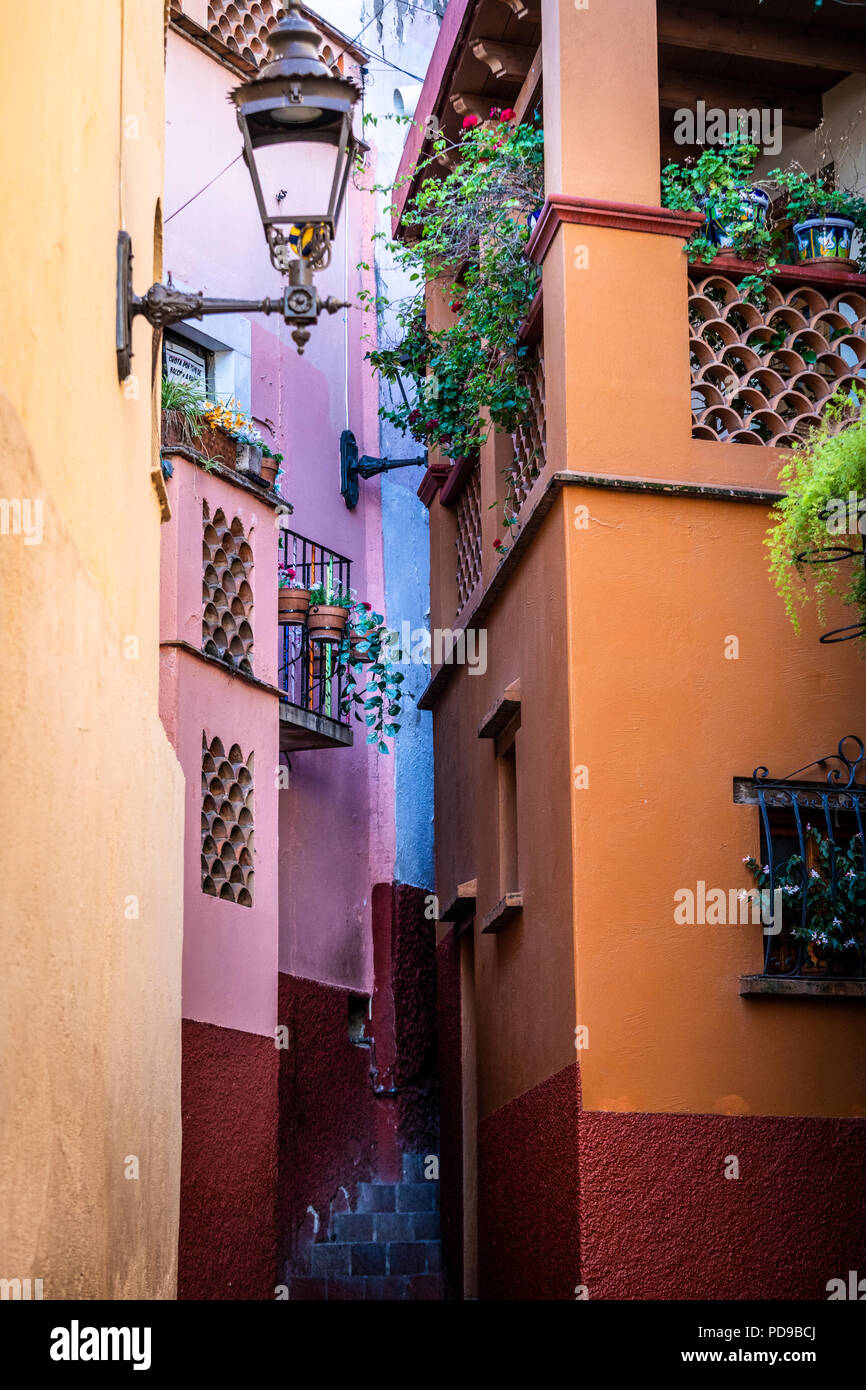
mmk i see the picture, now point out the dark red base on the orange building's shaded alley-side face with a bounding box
[478,1063,580,1301]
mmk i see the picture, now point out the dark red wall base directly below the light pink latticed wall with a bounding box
[178,1019,278,1300]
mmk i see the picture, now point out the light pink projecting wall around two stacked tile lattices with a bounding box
[160,456,279,1037]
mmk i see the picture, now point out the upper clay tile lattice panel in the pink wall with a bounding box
[202,502,253,676]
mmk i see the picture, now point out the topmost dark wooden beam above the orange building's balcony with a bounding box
[659,4,866,72]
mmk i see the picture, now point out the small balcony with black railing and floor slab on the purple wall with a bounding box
[278,531,353,752]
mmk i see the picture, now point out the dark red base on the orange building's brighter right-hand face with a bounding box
[575,1111,866,1300]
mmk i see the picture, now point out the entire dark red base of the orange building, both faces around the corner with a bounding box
[469,1065,866,1301]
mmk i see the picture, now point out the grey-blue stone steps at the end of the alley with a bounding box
[289,1154,443,1302]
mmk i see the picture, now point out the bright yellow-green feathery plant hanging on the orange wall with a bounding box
[766,391,866,632]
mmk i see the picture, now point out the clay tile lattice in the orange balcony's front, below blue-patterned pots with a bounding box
[688,274,866,449]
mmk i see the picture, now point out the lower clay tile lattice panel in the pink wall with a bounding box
[202,730,256,908]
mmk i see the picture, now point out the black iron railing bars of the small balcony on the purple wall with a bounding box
[278,531,352,724]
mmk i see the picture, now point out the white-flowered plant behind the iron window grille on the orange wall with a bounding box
[742,826,866,951]
